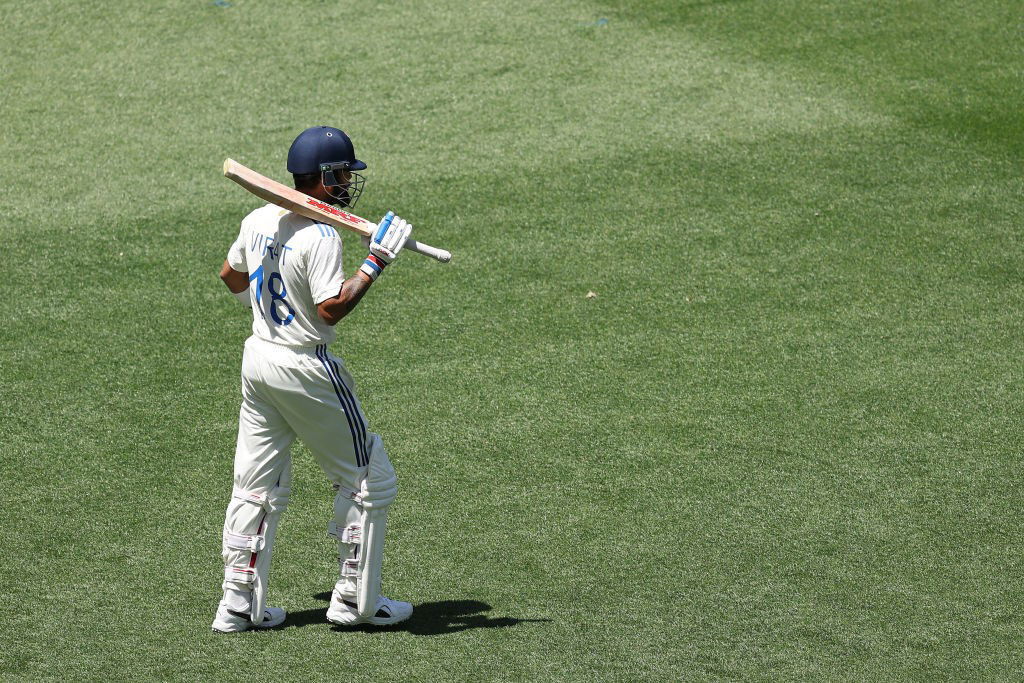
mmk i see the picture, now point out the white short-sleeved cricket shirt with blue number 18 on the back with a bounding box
[227,204,345,346]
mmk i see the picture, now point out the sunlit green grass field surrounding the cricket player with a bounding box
[0,0,1024,681]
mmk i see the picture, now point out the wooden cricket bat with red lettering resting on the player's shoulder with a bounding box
[224,159,452,263]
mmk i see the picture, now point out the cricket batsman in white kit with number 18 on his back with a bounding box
[213,126,413,633]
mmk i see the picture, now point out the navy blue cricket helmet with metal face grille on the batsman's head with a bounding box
[288,126,367,207]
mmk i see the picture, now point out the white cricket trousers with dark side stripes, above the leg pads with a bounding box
[234,337,371,492]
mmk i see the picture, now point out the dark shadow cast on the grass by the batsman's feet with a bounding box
[280,592,551,636]
